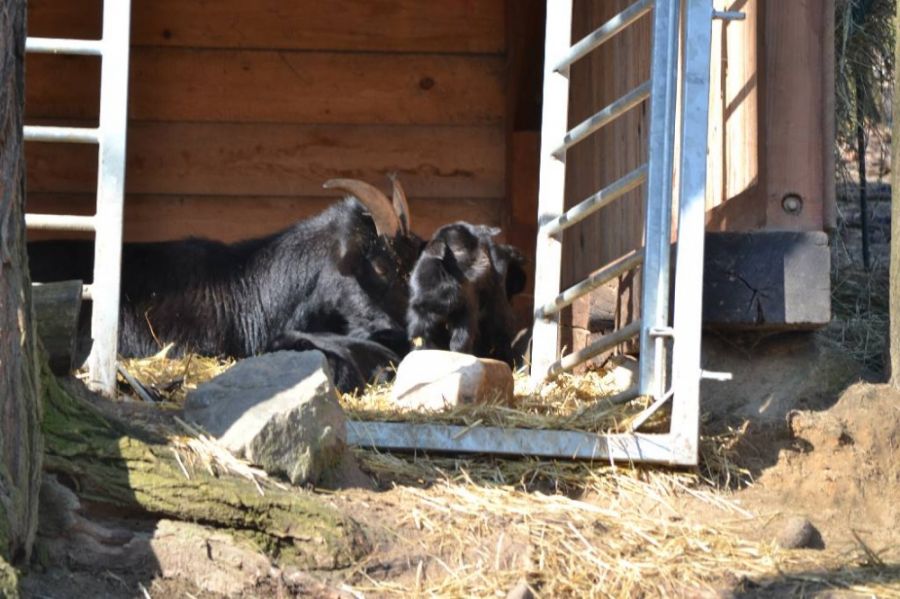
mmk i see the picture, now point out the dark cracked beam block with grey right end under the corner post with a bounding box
[703,231,831,330]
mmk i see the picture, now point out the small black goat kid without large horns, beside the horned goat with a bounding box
[407,222,525,365]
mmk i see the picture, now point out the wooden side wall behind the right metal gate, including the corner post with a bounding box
[562,0,834,349]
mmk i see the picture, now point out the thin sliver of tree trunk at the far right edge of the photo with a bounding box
[888,0,900,389]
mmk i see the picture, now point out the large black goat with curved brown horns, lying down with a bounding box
[28,179,422,391]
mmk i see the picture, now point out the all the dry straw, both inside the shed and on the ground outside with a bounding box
[119,354,900,597]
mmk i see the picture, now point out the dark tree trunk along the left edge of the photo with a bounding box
[0,0,42,584]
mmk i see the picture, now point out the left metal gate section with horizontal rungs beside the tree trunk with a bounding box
[25,0,131,394]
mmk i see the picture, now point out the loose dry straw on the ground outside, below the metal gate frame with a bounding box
[344,462,900,597]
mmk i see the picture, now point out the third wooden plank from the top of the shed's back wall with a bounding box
[26,122,505,198]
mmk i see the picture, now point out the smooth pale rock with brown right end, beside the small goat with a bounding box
[391,349,513,411]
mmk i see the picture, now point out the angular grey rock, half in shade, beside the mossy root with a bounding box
[185,351,347,484]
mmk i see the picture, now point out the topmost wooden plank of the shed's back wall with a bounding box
[28,0,506,53]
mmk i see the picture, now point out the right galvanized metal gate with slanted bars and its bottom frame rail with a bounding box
[348,0,728,465]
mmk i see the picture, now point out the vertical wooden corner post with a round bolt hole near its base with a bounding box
[764,0,833,231]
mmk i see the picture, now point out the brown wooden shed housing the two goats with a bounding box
[26,0,834,356]
